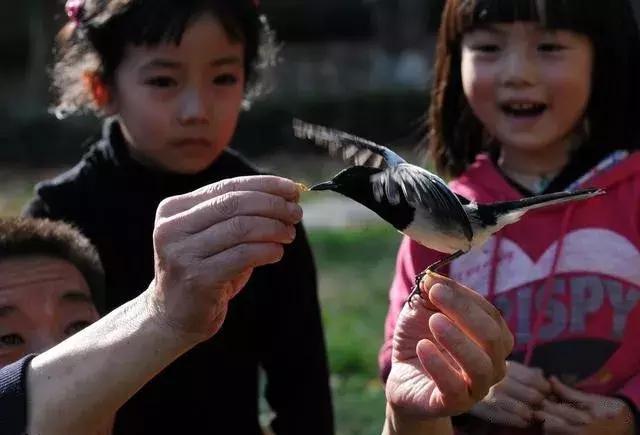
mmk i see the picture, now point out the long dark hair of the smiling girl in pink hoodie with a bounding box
[428,0,640,176]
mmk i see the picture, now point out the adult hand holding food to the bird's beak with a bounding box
[149,176,302,341]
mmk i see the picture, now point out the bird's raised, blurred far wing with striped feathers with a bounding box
[293,119,406,168]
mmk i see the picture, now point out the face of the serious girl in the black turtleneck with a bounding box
[109,14,245,174]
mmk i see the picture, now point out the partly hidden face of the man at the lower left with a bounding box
[0,256,99,367]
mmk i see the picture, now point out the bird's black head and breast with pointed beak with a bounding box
[310,166,415,231]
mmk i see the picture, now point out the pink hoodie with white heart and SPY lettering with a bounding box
[379,152,640,433]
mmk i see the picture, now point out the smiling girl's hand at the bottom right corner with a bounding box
[535,377,635,435]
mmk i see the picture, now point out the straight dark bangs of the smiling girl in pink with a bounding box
[456,0,609,35]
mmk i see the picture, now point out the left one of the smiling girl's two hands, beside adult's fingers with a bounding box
[471,361,551,428]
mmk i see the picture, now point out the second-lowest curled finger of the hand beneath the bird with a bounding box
[429,313,496,400]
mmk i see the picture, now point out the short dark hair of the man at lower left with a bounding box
[0,218,105,313]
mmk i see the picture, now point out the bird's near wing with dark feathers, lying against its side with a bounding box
[371,163,473,240]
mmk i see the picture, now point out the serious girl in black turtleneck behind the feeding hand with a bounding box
[26,0,333,434]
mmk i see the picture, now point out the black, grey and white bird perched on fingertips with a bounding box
[293,119,605,302]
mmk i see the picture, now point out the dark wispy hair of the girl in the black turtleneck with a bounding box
[53,0,277,117]
